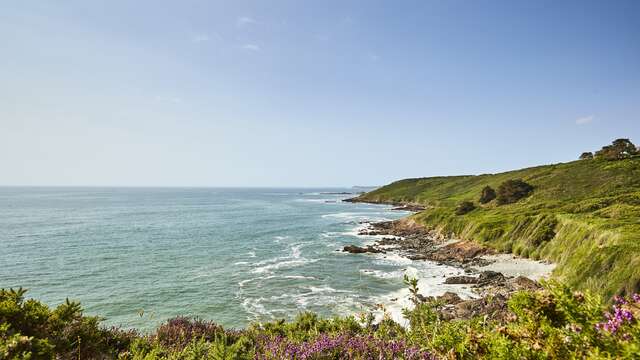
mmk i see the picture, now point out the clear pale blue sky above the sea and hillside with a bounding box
[0,0,640,187]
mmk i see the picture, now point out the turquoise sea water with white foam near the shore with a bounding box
[0,188,470,330]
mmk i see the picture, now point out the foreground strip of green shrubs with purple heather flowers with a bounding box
[0,279,640,360]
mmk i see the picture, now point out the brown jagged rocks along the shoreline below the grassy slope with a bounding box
[342,218,552,320]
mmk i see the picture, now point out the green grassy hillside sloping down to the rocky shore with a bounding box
[358,156,640,298]
